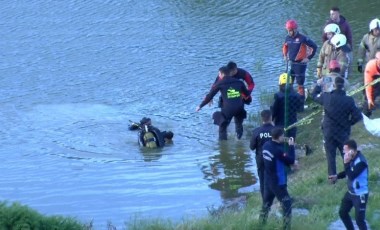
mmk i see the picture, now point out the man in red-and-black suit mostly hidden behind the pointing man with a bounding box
[210,61,255,108]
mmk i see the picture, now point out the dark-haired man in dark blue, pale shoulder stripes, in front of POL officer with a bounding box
[260,127,296,229]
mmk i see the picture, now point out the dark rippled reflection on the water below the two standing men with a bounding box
[201,143,256,199]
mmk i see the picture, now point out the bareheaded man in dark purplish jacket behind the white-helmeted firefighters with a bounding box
[322,6,353,49]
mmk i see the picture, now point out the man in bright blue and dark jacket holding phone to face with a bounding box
[330,140,368,230]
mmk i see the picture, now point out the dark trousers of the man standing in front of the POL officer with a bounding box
[260,182,292,229]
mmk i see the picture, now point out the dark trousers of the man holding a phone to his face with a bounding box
[339,192,368,230]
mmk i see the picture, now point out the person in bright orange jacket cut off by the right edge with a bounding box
[363,51,380,116]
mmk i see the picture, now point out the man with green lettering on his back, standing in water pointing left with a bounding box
[196,66,249,140]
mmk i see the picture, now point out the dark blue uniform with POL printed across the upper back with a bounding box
[249,123,274,200]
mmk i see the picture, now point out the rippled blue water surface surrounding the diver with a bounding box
[0,0,378,229]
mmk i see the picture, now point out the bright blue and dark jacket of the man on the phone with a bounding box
[338,151,368,195]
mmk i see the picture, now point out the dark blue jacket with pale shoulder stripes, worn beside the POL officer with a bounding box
[263,140,295,186]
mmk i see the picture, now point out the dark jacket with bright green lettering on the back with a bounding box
[199,77,249,119]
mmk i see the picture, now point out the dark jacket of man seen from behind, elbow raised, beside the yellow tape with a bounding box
[312,86,362,141]
